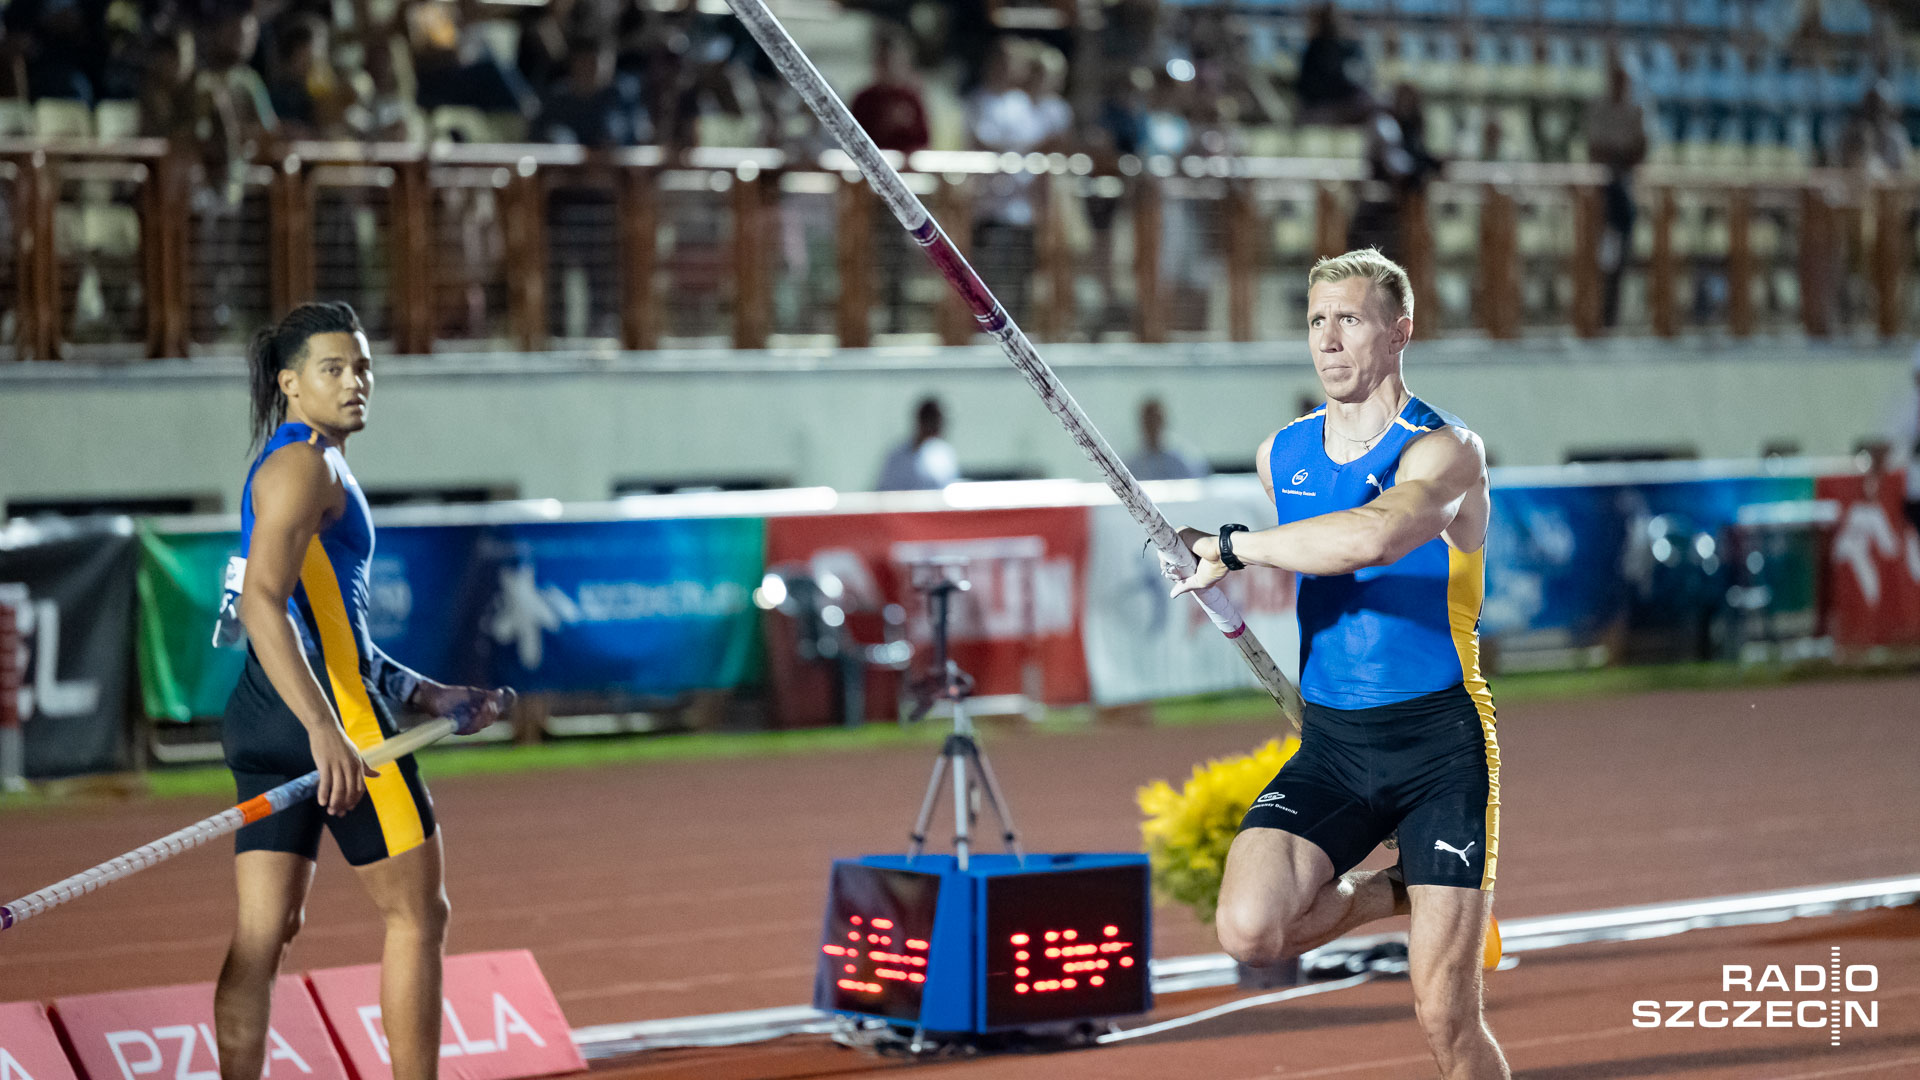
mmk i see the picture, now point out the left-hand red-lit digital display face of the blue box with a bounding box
[814,865,941,1020]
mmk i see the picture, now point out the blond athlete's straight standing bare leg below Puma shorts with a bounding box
[1407,884,1511,1080]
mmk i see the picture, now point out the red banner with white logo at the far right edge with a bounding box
[1814,473,1920,648]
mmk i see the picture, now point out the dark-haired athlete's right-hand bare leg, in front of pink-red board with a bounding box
[353,830,447,1080]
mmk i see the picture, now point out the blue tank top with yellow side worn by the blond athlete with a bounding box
[1267,390,1494,717]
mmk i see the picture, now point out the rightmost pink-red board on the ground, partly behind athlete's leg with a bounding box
[307,949,586,1080]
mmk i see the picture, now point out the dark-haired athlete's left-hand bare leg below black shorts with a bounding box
[213,851,313,1080]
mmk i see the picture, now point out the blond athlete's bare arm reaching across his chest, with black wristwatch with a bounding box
[1187,427,1486,588]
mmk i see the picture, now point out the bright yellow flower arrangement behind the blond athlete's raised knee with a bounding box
[1137,738,1300,922]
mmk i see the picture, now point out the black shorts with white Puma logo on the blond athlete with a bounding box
[1240,686,1500,890]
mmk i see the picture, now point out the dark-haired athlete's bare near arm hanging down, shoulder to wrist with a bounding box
[240,446,342,732]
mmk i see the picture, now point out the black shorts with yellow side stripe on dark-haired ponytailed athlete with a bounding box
[221,650,434,867]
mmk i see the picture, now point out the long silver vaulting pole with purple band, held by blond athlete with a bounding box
[728,0,1300,726]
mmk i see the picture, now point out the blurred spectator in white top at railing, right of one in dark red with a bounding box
[968,37,1054,321]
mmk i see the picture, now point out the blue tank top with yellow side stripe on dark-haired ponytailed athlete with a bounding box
[240,423,380,722]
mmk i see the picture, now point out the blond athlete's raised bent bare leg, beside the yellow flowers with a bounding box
[1213,828,1405,967]
